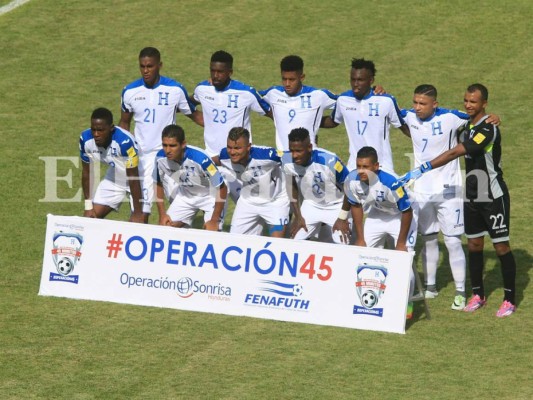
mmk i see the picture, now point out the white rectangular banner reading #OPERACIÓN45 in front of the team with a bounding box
[39,215,413,333]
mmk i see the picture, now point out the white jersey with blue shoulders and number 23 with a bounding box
[194,80,270,157]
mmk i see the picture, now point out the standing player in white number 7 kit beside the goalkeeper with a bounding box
[402,85,468,310]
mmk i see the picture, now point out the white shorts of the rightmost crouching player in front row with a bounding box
[364,209,417,250]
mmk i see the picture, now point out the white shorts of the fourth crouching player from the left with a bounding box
[294,200,342,243]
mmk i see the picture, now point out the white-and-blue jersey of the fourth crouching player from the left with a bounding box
[282,148,348,207]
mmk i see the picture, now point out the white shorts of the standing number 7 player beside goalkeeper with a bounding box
[415,193,464,236]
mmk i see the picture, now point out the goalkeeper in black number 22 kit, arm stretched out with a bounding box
[401,83,516,317]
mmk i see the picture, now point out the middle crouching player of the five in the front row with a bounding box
[217,127,289,237]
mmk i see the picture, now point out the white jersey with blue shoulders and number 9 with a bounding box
[259,86,337,151]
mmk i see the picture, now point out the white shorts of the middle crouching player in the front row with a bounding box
[230,194,289,235]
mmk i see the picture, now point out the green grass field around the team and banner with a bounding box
[0,0,533,399]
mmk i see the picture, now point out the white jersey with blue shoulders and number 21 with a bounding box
[122,76,195,155]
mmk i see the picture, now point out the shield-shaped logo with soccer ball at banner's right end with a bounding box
[353,264,387,318]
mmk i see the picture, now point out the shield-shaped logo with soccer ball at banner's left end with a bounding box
[49,231,83,285]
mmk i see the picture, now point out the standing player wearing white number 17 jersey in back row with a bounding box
[321,58,409,173]
